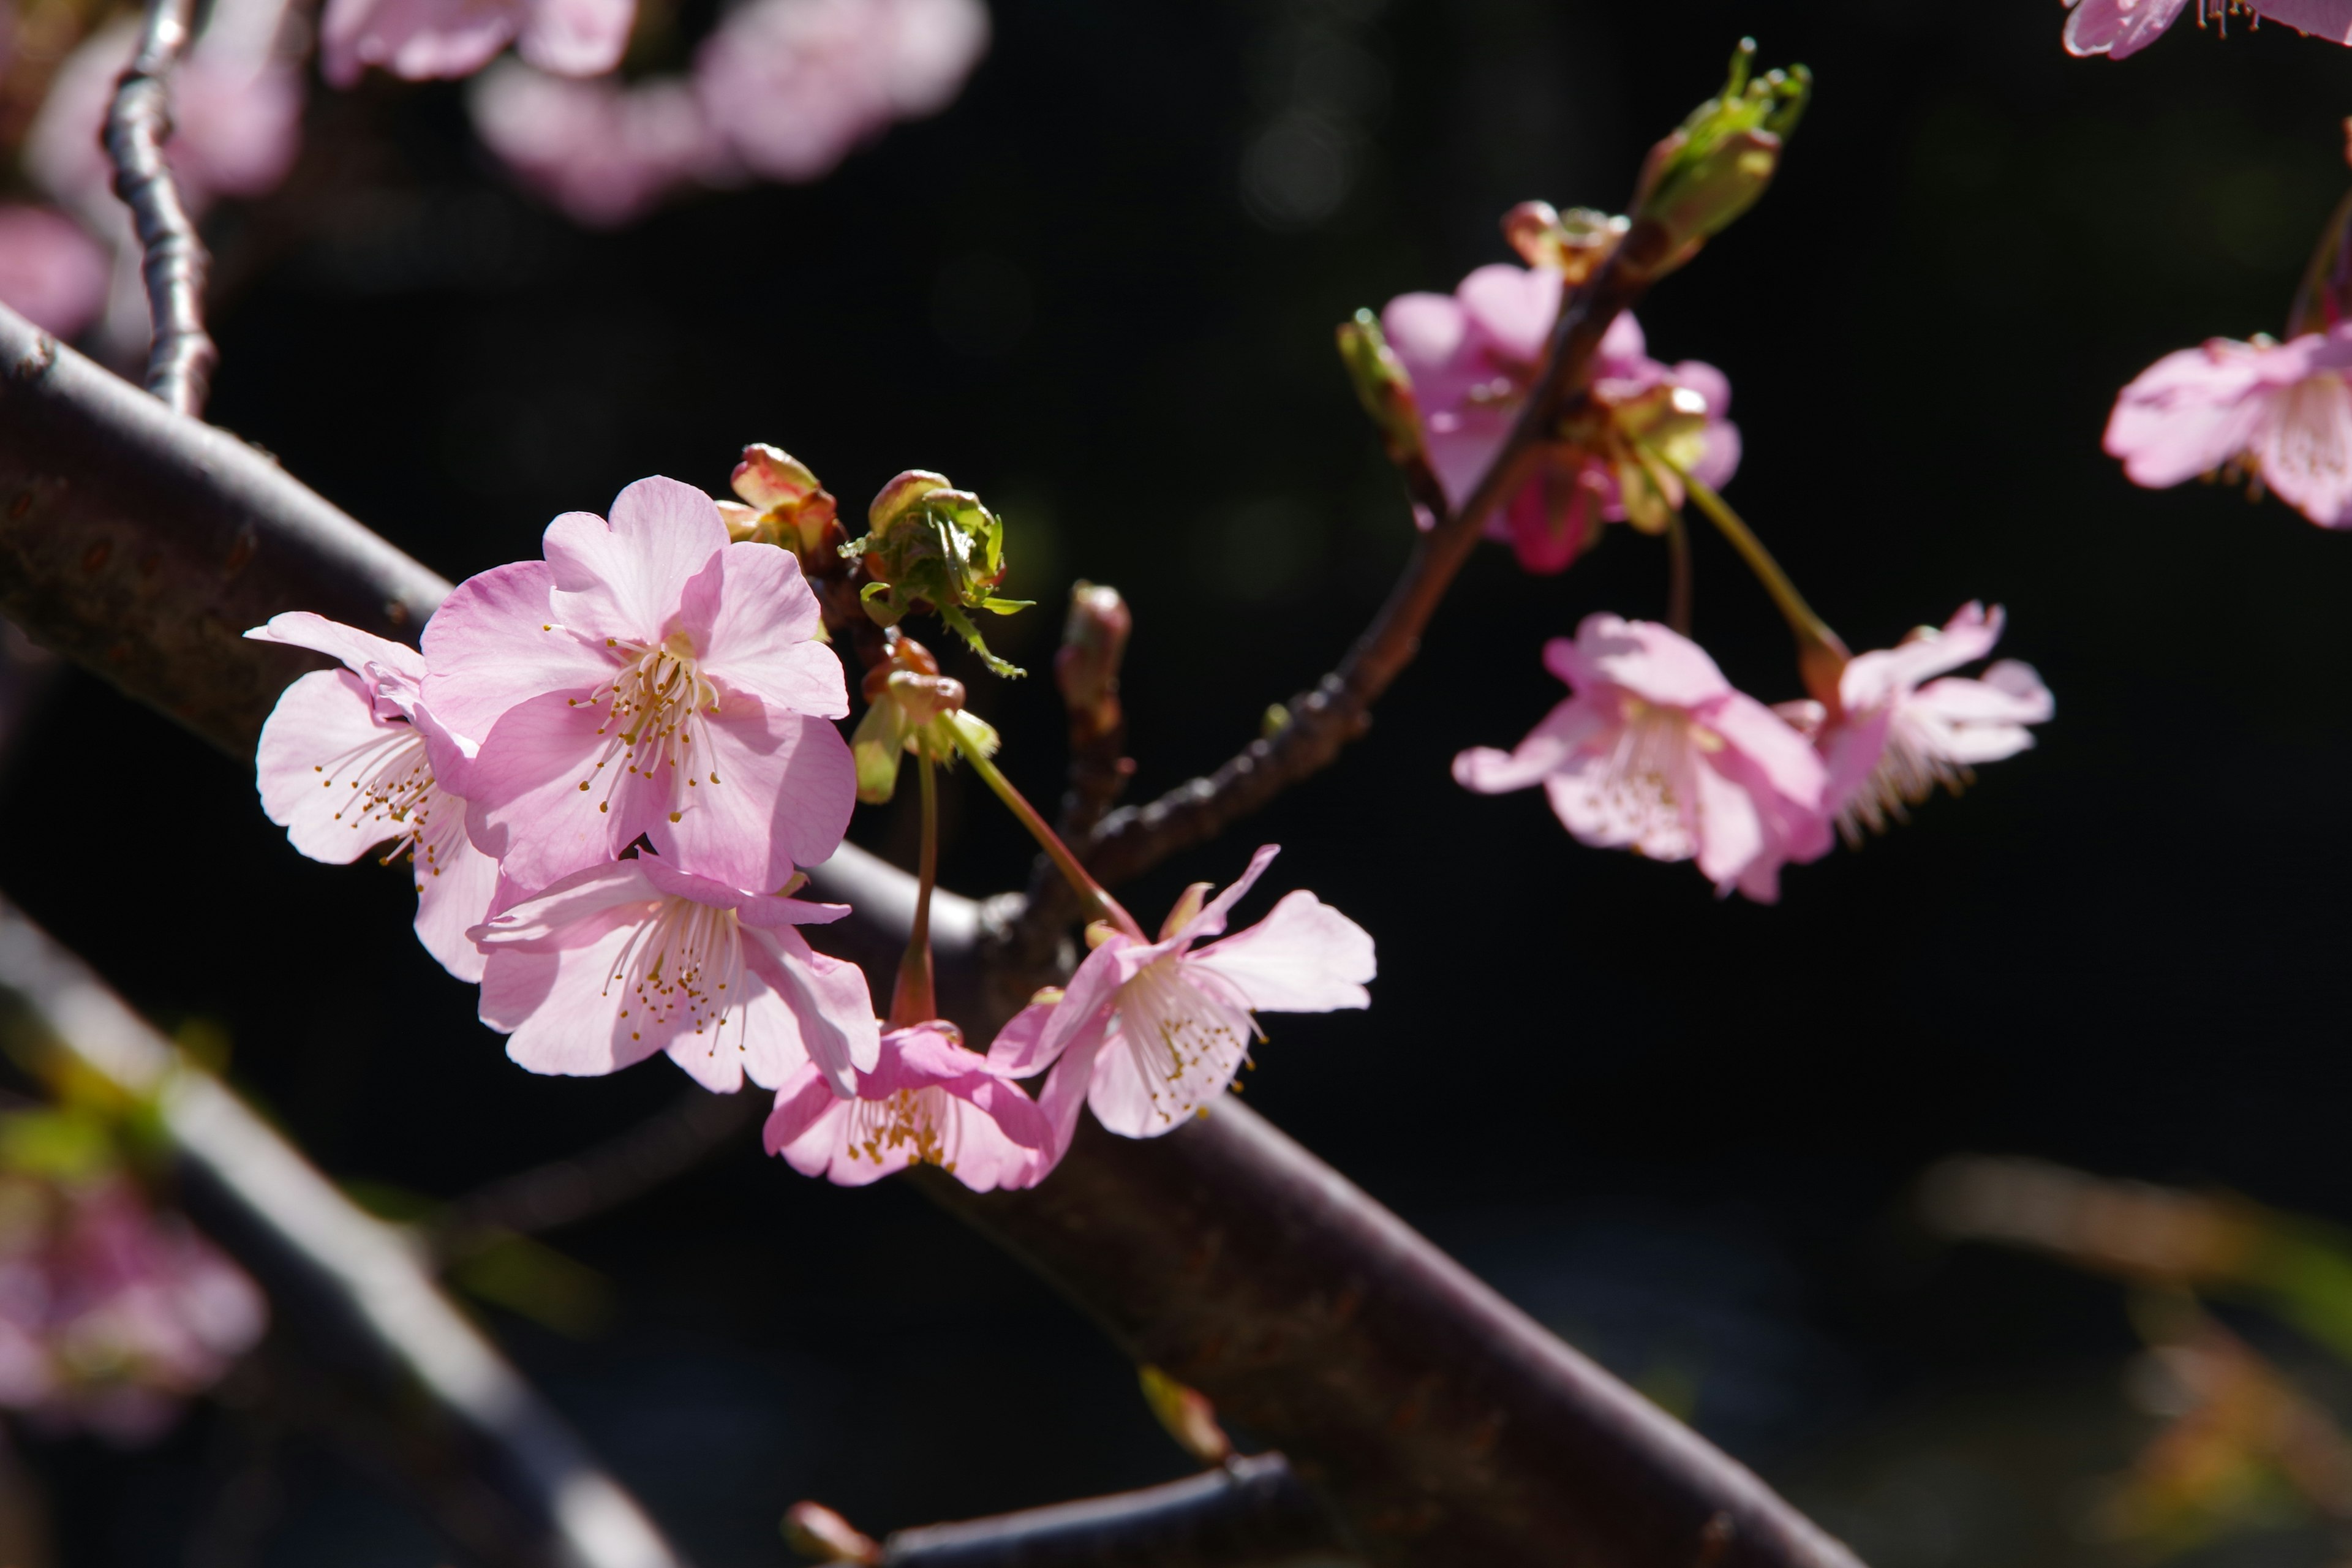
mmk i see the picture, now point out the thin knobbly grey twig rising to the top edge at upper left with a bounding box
[106,0,221,418]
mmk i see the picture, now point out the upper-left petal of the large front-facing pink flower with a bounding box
[423,562,619,738]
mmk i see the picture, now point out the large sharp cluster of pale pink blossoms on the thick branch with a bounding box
[249,463,1374,1189]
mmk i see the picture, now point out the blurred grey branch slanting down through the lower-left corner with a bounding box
[0,900,682,1568]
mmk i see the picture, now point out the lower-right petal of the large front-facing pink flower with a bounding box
[649,700,859,889]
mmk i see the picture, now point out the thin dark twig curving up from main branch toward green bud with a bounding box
[1077,239,1656,886]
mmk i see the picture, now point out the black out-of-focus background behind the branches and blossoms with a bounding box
[0,0,2352,1568]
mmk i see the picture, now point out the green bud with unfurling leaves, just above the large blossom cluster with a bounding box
[840,468,1030,677]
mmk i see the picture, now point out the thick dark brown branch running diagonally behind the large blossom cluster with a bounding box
[0,301,1853,1568]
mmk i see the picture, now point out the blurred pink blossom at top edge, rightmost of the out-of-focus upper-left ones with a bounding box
[694,0,988,183]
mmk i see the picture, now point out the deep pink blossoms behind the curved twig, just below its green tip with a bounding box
[1381,263,1741,571]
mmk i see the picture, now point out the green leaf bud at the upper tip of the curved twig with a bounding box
[1627,37,1814,277]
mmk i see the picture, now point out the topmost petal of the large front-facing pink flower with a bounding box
[546,477,727,644]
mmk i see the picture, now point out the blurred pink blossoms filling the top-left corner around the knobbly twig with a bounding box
[0,0,988,338]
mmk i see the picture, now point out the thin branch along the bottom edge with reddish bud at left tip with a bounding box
[786,1453,1355,1568]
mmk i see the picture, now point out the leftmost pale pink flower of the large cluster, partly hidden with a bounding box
[244,611,499,980]
